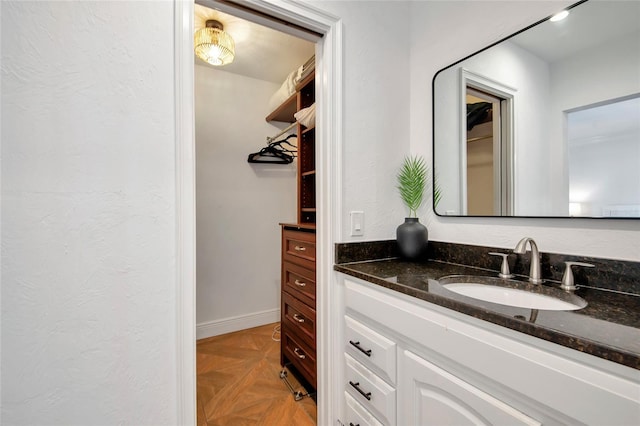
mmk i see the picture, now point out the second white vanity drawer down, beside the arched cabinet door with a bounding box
[344,354,396,425]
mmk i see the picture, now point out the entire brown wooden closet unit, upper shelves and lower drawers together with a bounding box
[267,69,317,392]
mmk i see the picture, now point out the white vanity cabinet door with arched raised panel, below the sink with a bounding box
[398,350,541,426]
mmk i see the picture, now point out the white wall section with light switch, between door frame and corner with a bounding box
[305,0,411,236]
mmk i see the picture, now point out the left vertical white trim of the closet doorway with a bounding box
[174,0,196,426]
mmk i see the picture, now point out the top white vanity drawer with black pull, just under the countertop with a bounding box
[344,315,396,385]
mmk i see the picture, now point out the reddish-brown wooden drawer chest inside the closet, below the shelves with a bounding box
[280,224,317,390]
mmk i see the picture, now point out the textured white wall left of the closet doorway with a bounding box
[0,1,176,425]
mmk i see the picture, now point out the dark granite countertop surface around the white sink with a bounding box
[334,259,640,370]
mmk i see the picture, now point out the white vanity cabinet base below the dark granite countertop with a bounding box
[338,274,640,426]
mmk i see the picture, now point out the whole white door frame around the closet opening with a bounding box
[174,0,343,425]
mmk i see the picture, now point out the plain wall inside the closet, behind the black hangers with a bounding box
[195,66,297,338]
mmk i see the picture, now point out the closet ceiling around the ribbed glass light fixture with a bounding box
[193,4,315,84]
